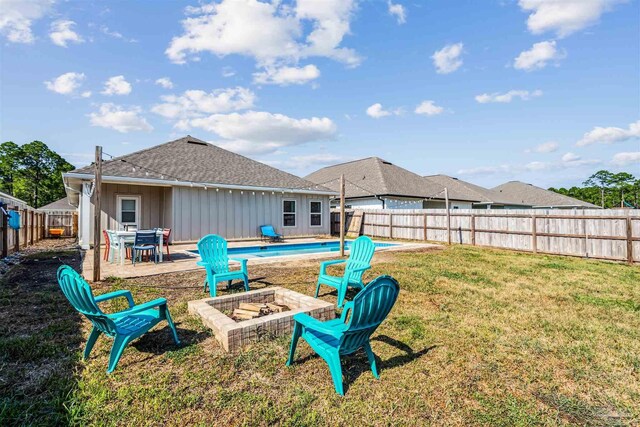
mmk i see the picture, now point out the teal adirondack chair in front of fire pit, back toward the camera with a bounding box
[287,276,400,395]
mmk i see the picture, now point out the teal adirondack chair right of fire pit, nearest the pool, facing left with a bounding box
[315,236,376,307]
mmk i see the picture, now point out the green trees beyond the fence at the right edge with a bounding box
[549,170,640,209]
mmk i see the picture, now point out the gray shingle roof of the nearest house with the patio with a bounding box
[70,135,330,191]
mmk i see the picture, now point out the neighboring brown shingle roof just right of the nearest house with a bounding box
[305,157,444,199]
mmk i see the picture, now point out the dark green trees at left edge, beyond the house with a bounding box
[0,141,75,208]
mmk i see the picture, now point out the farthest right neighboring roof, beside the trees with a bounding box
[493,181,600,209]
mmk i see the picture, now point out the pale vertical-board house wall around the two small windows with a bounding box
[172,187,331,242]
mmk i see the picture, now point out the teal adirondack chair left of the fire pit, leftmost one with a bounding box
[58,265,180,373]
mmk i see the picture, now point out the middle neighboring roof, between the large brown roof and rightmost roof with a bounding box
[424,175,531,209]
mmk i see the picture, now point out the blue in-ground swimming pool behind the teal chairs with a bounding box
[189,240,398,258]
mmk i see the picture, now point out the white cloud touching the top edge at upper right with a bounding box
[519,0,621,37]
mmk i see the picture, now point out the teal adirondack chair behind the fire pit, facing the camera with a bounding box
[196,234,249,297]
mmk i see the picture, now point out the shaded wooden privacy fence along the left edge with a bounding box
[0,198,45,258]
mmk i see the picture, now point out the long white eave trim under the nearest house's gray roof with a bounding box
[63,172,338,196]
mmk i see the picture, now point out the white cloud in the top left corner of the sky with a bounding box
[0,0,55,43]
